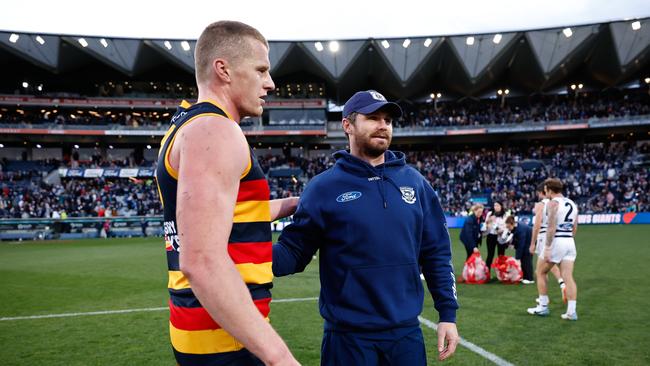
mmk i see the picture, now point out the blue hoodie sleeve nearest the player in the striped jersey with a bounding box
[272,186,323,277]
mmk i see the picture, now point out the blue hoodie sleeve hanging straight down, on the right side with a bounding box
[420,183,458,323]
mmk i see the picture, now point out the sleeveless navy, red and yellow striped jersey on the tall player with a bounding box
[156,101,273,364]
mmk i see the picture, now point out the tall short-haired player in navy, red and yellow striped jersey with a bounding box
[156,21,298,366]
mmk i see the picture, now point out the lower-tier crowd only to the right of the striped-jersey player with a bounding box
[260,143,650,216]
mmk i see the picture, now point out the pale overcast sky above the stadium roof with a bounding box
[0,0,650,40]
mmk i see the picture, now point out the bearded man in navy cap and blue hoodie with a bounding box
[273,90,460,366]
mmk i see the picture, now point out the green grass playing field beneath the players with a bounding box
[0,225,650,365]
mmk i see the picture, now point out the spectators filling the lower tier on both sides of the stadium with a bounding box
[0,142,650,218]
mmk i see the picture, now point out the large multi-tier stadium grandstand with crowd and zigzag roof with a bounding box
[0,18,650,240]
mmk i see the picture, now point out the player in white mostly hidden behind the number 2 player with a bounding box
[522,182,566,303]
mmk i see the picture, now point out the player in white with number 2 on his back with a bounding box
[528,178,578,320]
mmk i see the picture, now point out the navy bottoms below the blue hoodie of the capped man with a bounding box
[321,326,427,366]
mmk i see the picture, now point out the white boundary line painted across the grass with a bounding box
[0,297,514,366]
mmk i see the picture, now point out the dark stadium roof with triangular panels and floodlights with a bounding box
[0,18,650,101]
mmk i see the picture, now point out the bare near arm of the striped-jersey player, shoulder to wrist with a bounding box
[172,117,295,364]
